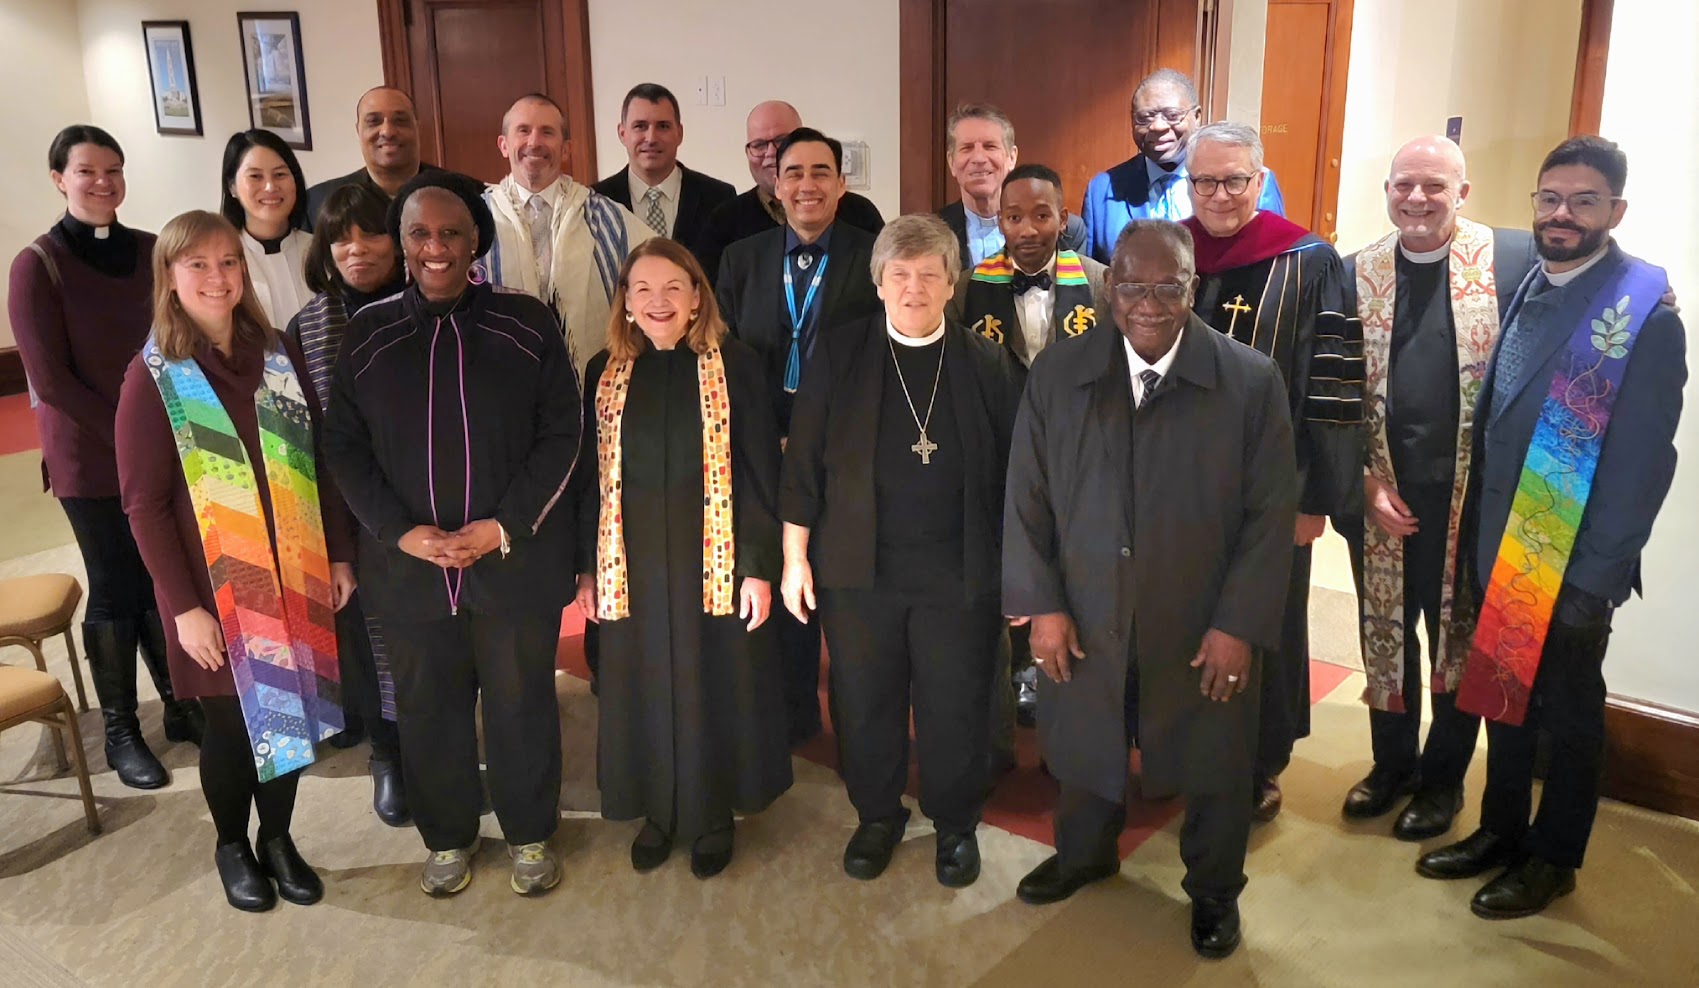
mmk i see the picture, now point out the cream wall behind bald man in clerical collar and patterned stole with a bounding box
[1339,0,1583,251]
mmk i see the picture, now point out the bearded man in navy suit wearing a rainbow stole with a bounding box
[1417,138,1687,918]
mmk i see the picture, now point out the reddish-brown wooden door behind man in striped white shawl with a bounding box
[379,0,596,183]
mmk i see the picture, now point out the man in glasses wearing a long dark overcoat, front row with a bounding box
[1002,221,1298,957]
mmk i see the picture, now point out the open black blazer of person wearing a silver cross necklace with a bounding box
[778,312,1021,601]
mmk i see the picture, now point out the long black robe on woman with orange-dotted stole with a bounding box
[578,340,792,840]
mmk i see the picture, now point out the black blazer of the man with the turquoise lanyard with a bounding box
[714,222,885,436]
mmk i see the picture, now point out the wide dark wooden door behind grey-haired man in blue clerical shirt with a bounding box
[899,0,1201,212]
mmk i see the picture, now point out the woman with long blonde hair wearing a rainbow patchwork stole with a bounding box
[116,211,353,912]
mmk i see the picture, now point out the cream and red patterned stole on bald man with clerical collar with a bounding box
[1358,217,1499,713]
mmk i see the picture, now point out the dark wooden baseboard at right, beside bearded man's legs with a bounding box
[1604,696,1699,820]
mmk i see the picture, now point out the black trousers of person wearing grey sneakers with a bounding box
[384,608,561,850]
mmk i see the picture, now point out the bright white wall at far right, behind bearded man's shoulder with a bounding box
[1600,0,1699,711]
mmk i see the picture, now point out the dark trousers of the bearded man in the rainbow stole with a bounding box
[1482,604,1611,867]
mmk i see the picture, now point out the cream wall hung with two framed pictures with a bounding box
[75,0,384,231]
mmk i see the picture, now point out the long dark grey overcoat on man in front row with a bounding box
[1002,316,1298,801]
